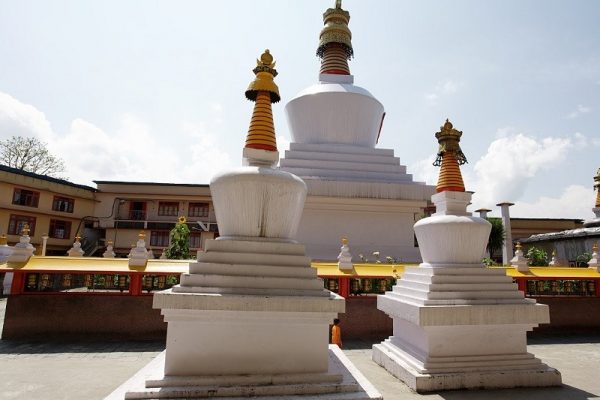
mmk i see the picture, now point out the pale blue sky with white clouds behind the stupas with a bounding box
[0,0,600,218]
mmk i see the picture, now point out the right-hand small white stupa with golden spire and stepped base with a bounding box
[373,120,561,392]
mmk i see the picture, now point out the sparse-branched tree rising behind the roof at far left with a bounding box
[0,136,65,179]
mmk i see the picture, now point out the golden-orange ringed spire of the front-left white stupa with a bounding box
[245,50,281,151]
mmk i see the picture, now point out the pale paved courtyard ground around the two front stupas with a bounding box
[0,299,600,400]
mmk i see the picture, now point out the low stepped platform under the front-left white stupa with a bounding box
[105,345,382,400]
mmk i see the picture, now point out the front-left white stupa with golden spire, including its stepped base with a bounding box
[109,50,381,400]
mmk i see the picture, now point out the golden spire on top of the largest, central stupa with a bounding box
[317,0,354,75]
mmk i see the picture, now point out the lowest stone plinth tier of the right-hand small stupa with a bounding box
[373,340,561,393]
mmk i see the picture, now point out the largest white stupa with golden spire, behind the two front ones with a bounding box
[280,0,435,261]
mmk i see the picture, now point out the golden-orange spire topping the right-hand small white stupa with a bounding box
[433,119,467,193]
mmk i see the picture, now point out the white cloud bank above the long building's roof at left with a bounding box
[0,92,232,185]
